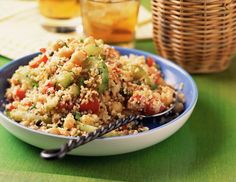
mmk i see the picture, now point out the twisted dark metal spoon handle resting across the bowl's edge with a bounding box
[40,115,142,159]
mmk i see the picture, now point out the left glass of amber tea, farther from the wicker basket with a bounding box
[38,0,80,32]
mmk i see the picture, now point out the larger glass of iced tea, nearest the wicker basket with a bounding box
[80,0,140,44]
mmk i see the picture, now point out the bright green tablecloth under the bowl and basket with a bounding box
[0,1,236,182]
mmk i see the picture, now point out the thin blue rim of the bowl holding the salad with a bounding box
[0,46,198,141]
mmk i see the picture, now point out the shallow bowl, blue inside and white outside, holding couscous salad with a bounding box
[0,47,198,156]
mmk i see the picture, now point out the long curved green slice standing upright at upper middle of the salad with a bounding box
[98,61,109,93]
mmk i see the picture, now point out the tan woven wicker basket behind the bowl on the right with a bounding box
[152,0,236,73]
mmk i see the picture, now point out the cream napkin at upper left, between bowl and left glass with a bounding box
[0,9,79,59]
